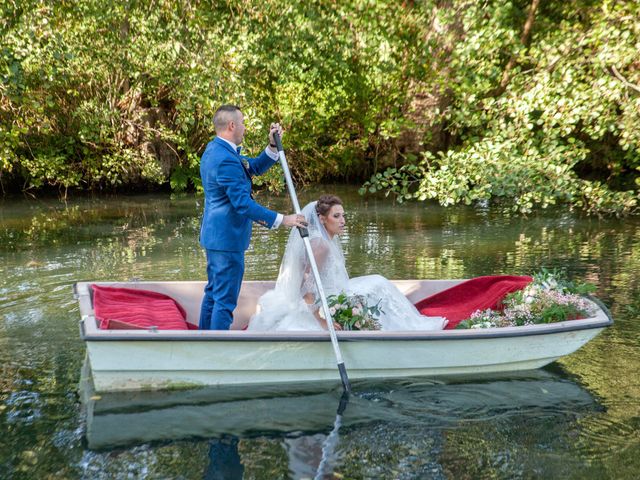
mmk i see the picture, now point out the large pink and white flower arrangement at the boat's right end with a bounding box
[456,269,595,328]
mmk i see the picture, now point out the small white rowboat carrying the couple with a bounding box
[74,280,613,392]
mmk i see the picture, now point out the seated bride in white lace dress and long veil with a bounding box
[248,195,447,331]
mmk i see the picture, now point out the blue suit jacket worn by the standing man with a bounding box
[200,137,277,252]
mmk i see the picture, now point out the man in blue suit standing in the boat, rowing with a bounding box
[200,105,306,330]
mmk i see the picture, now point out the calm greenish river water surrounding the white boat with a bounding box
[0,187,640,479]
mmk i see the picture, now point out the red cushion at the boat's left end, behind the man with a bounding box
[91,285,198,330]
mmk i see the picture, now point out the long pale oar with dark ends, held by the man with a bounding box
[273,133,351,394]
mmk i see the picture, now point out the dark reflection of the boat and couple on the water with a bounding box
[81,364,600,478]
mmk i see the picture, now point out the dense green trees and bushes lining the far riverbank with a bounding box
[0,0,640,215]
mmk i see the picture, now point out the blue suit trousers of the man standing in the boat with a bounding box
[200,250,244,330]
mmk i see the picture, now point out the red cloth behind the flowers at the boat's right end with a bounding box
[416,275,533,330]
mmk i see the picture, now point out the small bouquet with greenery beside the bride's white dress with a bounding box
[320,292,382,330]
